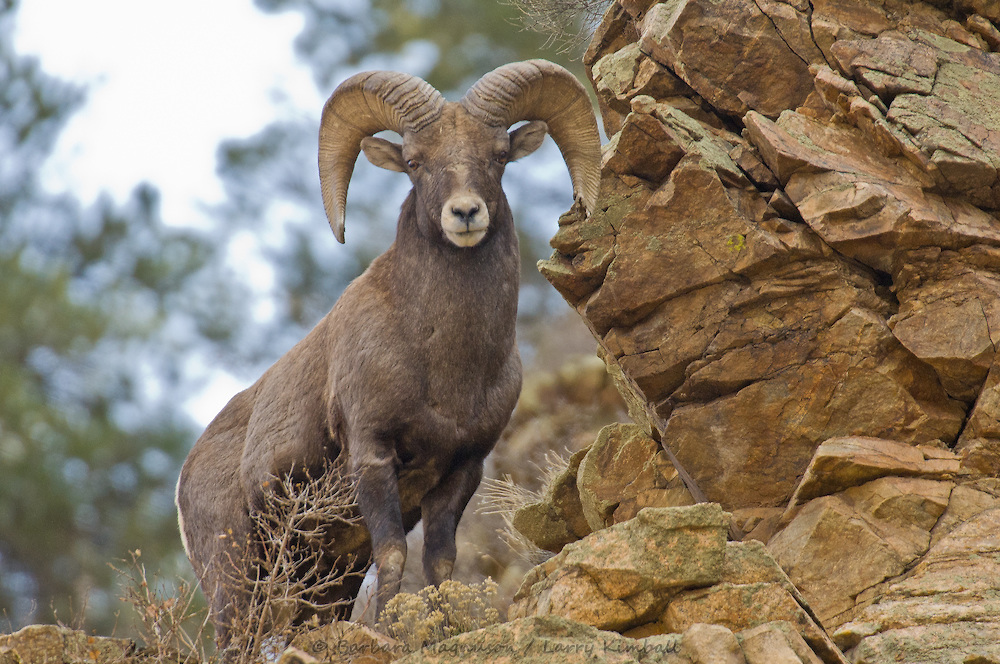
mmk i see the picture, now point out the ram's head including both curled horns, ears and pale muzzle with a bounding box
[319,60,600,247]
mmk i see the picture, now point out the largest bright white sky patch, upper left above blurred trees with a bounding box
[15,0,323,224]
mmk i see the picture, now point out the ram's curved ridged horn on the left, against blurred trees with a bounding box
[319,71,445,243]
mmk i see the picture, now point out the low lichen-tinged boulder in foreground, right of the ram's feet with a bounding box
[510,503,846,663]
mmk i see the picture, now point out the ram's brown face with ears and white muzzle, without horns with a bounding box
[361,104,546,247]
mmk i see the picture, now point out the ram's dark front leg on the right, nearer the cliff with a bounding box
[420,458,483,586]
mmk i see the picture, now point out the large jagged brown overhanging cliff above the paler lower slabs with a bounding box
[540,0,1000,509]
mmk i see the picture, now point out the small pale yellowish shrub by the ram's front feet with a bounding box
[378,579,500,652]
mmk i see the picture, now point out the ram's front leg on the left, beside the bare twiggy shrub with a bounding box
[355,457,406,615]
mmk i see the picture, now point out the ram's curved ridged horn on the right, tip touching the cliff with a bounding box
[461,60,601,214]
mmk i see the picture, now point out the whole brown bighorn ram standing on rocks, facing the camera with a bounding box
[177,60,600,644]
